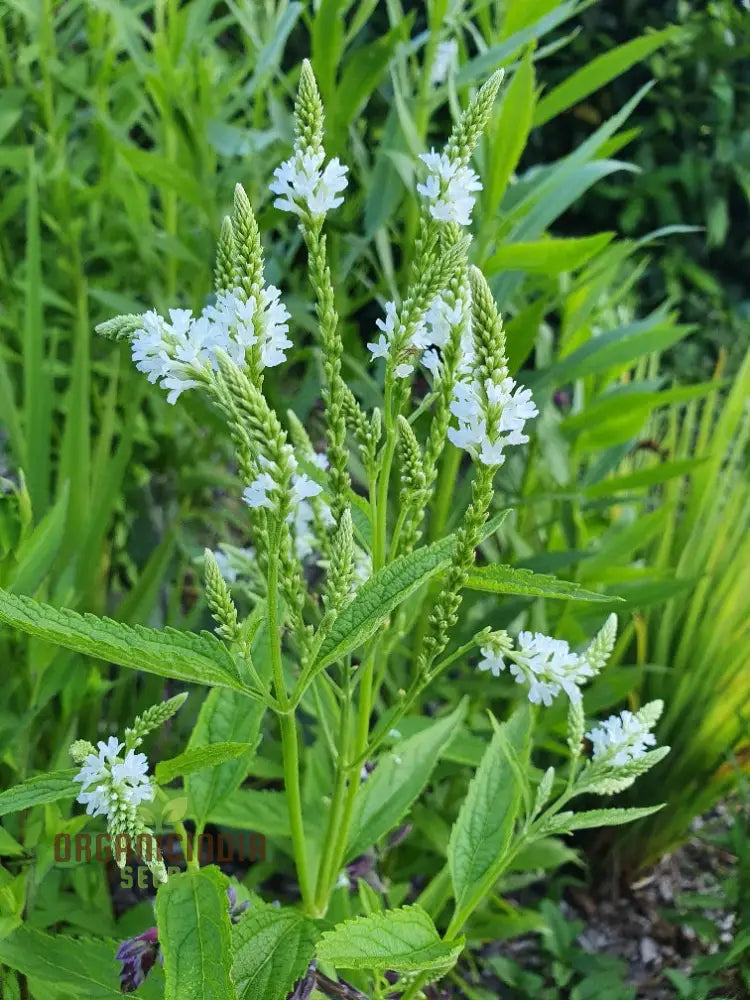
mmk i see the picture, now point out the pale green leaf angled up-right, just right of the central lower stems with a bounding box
[345,700,466,861]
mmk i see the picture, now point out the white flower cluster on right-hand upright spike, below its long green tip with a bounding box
[448,376,539,465]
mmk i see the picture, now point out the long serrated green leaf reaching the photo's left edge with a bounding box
[0,590,244,691]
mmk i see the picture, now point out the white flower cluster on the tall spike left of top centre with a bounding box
[271,149,348,217]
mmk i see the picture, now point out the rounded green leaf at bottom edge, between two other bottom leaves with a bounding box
[232,905,317,1000]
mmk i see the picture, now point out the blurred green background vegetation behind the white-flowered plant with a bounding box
[0,0,750,997]
